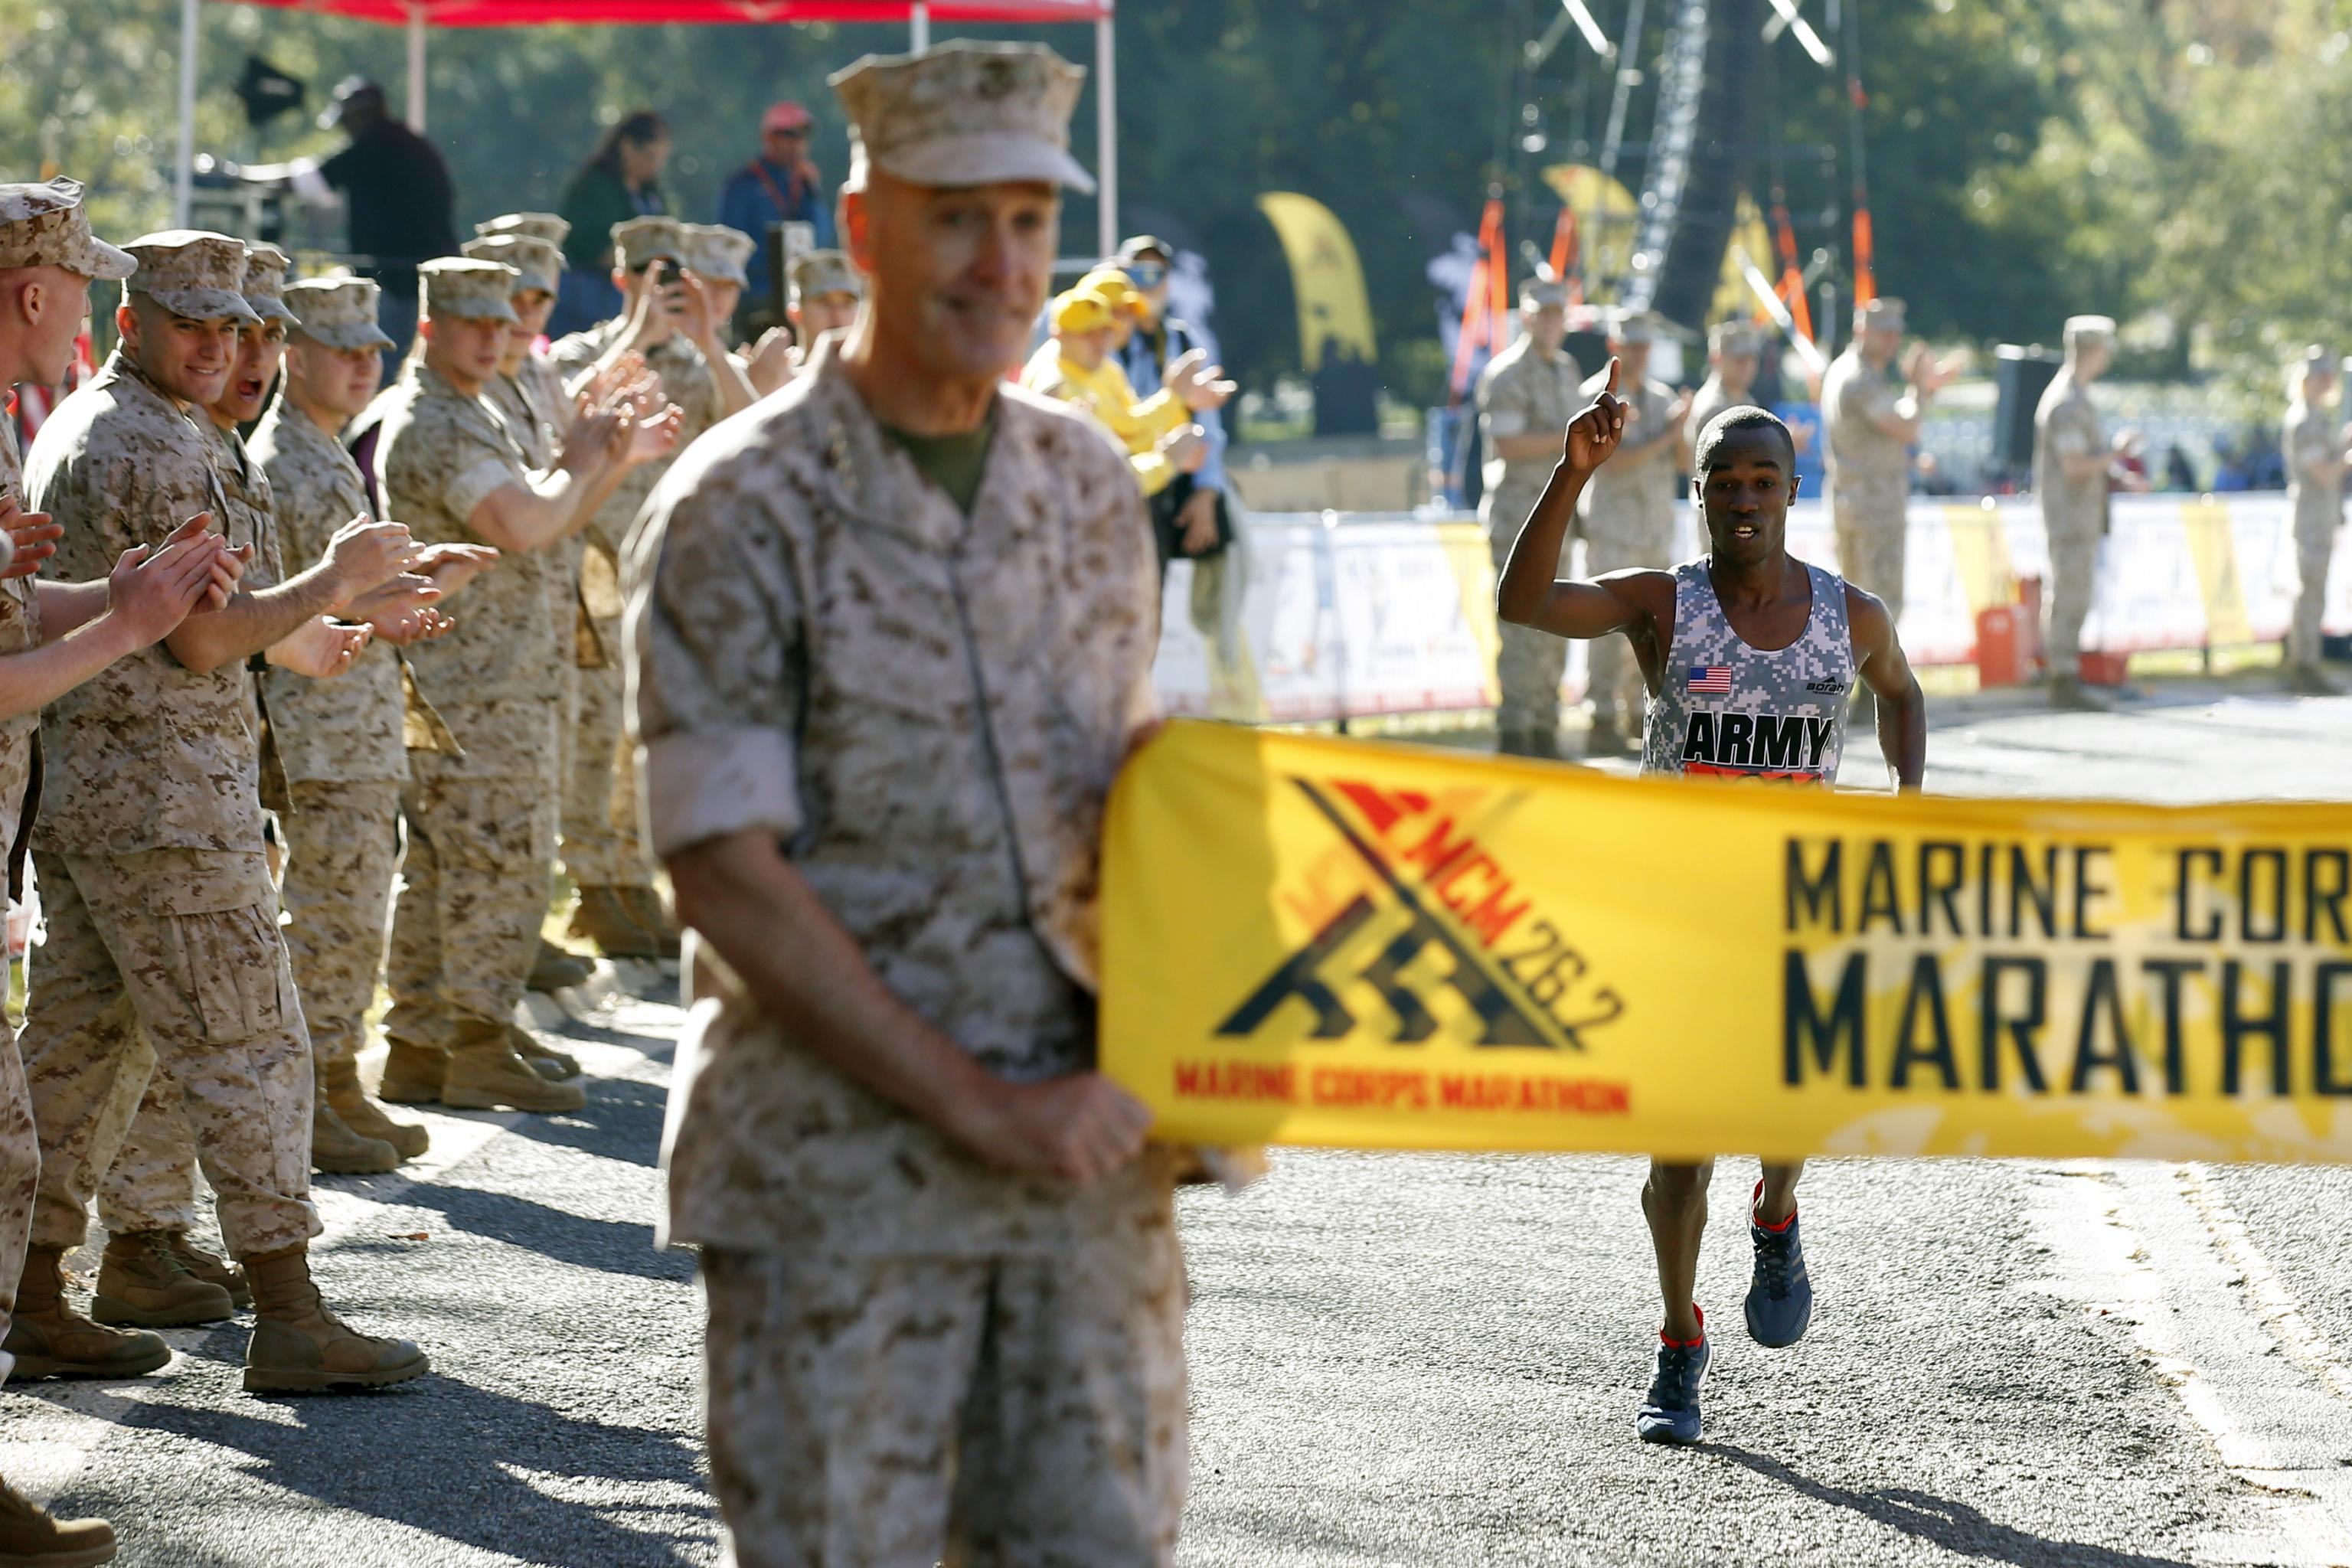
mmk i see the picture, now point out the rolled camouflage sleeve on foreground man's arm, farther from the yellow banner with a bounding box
[623,485,805,858]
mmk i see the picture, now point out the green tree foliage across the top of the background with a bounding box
[0,0,2352,400]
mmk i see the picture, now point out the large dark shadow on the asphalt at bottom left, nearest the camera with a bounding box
[41,1363,715,1568]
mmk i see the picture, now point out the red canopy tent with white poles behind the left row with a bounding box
[176,0,1119,256]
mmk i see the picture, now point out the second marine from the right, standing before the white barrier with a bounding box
[2034,315,2115,707]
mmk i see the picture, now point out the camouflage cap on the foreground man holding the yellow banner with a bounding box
[828,38,1093,193]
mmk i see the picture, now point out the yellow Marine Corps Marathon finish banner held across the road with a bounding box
[1103,712,2352,1161]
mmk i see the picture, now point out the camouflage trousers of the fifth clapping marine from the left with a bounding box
[384,753,555,1046]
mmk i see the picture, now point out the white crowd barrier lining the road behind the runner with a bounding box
[1152,492,2352,722]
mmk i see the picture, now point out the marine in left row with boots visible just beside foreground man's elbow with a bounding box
[548,219,722,957]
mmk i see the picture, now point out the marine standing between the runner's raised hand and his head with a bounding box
[1569,312,1691,757]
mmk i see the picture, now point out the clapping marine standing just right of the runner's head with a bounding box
[1821,299,1933,619]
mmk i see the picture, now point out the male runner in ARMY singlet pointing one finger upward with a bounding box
[1496,360,1926,1443]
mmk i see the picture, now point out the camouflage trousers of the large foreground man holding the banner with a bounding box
[704,1210,1187,1568]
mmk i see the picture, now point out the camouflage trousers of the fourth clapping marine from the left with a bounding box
[280,778,400,1063]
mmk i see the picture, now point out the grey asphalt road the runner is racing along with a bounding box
[0,681,2352,1568]
